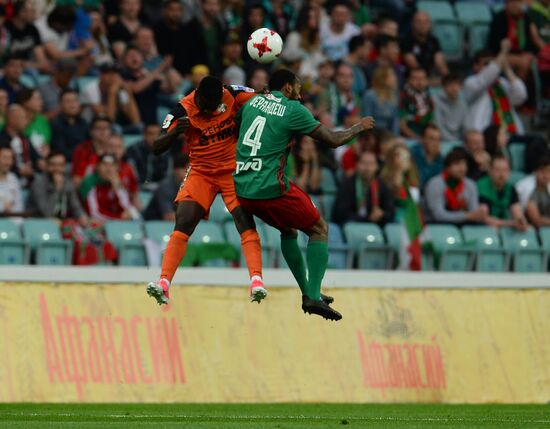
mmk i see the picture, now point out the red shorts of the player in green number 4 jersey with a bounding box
[239,182,321,231]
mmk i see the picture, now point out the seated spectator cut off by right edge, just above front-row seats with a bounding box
[525,158,550,228]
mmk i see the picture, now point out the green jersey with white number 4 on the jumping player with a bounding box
[233,91,320,200]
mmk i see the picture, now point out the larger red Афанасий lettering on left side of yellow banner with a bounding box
[39,294,186,400]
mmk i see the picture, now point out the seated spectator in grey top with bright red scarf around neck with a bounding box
[424,148,487,225]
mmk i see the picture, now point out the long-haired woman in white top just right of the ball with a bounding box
[282,5,326,81]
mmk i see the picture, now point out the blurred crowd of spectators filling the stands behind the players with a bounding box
[0,0,550,266]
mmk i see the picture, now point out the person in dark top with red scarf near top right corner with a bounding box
[487,0,536,80]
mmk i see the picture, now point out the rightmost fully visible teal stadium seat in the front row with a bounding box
[500,228,546,273]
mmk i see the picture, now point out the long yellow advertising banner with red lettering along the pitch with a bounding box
[0,283,550,403]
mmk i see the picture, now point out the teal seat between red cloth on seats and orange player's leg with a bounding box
[105,220,147,266]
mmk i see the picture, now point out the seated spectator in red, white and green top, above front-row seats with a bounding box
[78,154,136,221]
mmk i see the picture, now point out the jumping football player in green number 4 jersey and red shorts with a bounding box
[233,70,374,320]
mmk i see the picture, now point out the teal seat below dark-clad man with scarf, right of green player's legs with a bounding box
[344,222,393,270]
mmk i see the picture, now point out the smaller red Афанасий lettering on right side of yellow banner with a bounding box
[357,331,447,395]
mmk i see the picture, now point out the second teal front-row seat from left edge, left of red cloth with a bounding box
[23,219,73,265]
